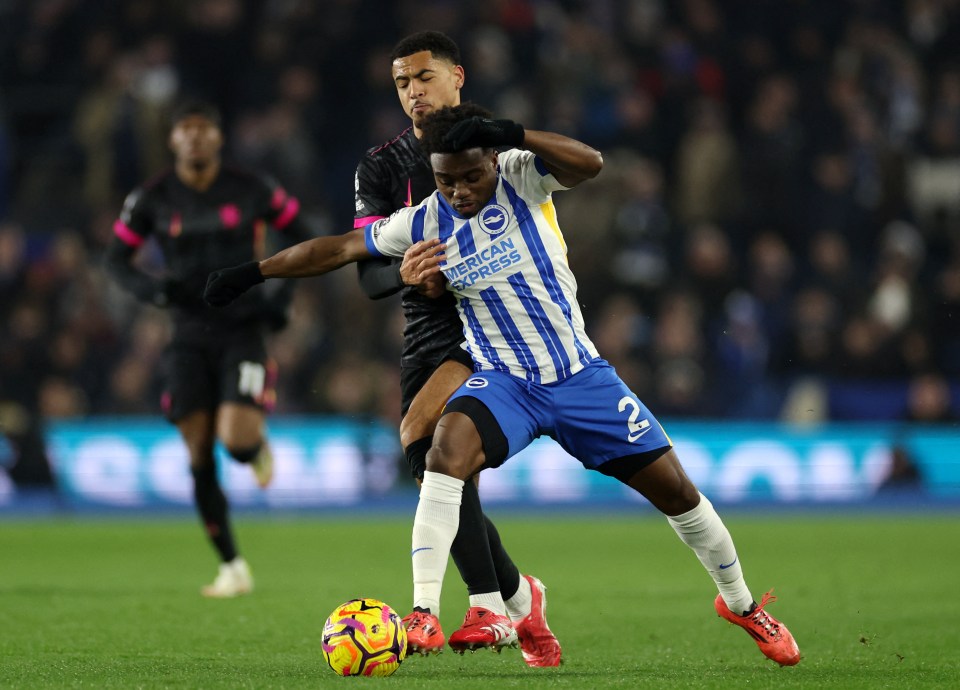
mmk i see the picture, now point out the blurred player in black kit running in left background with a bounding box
[107,101,310,598]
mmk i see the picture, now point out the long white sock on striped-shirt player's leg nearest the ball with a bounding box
[410,472,463,617]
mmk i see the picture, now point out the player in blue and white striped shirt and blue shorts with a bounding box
[206,104,800,665]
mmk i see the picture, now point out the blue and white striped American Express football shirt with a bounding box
[365,149,599,384]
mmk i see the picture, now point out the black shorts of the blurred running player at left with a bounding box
[161,327,277,423]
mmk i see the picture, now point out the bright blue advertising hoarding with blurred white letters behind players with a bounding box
[0,418,960,510]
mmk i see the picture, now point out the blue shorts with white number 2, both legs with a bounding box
[445,359,672,472]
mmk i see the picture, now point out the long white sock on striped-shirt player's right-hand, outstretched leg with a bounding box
[667,494,753,614]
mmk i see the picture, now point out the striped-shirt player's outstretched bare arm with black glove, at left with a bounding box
[203,229,371,307]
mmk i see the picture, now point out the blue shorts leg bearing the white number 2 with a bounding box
[550,361,671,473]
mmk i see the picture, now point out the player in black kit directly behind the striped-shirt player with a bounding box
[354,31,560,666]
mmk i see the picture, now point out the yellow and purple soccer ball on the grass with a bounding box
[322,599,407,676]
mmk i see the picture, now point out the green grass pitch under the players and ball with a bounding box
[0,513,960,690]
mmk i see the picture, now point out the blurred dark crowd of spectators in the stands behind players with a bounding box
[0,0,960,452]
